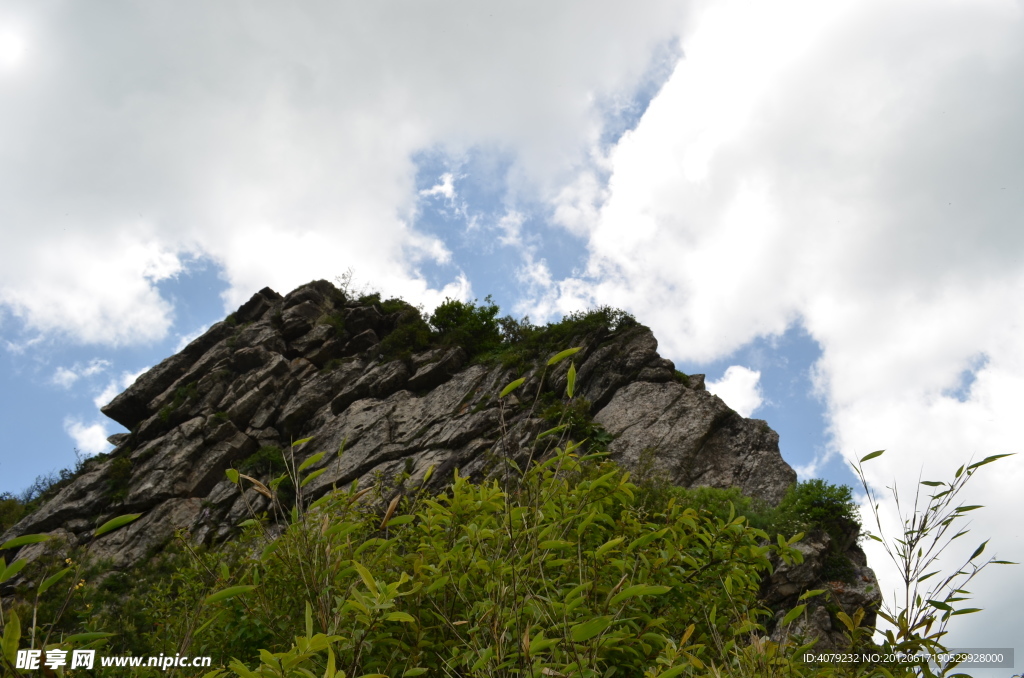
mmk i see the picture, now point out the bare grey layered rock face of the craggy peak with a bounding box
[3,281,880,647]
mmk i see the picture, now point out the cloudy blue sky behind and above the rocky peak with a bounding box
[0,0,1024,676]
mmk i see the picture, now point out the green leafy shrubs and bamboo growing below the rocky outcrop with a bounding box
[0,348,1002,678]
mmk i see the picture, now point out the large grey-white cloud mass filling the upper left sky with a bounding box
[0,0,684,345]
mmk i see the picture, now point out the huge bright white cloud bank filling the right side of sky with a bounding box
[551,0,1024,646]
